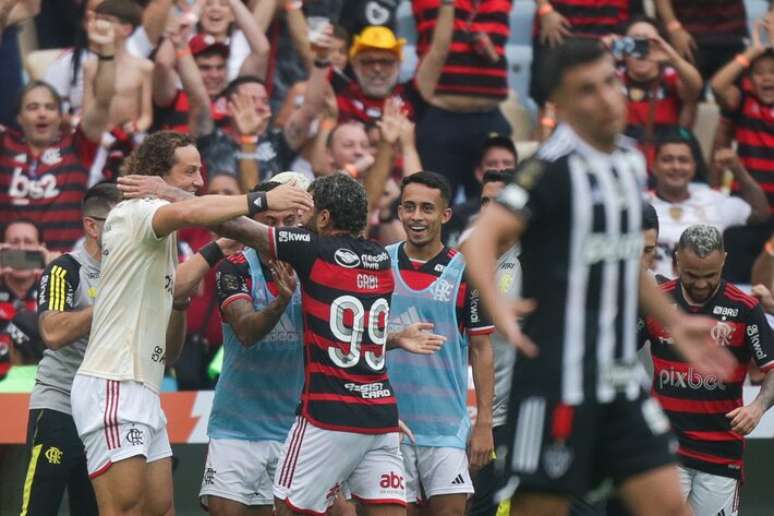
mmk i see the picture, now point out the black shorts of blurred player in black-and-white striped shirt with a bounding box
[496,391,677,500]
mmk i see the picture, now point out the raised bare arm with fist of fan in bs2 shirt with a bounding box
[81,16,117,142]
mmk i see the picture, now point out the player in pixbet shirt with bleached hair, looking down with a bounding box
[640,225,774,514]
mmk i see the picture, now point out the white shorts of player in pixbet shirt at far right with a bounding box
[680,466,739,516]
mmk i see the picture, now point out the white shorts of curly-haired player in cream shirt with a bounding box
[71,374,172,478]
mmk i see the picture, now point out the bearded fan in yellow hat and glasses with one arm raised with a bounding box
[332,0,454,124]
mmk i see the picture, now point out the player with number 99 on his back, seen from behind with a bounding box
[218,174,443,515]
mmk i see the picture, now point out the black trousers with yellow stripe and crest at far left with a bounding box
[21,409,99,516]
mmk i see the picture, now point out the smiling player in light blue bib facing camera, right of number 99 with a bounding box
[387,172,494,516]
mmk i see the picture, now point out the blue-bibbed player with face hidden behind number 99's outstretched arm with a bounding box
[199,173,309,516]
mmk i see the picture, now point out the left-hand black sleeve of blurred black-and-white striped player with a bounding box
[496,158,566,224]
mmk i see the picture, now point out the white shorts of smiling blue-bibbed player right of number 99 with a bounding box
[400,443,473,503]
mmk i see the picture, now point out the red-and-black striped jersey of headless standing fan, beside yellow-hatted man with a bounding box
[411,0,511,99]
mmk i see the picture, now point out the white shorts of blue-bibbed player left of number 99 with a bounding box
[199,439,282,507]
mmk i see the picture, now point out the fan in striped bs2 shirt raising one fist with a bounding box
[0,21,116,251]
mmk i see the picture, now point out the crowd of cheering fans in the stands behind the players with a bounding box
[0,0,774,488]
